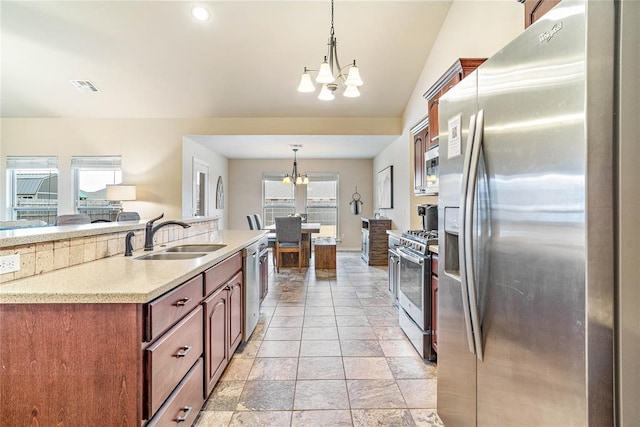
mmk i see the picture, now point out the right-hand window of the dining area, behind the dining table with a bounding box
[303,173,338,238]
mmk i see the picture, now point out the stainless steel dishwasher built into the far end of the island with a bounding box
[242,236,268,341]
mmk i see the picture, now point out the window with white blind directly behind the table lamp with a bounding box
[71,156,122,221]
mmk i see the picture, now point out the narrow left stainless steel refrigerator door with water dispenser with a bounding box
[437,69,477,426]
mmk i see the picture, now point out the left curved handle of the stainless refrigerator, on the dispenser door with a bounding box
[458,114,476,354]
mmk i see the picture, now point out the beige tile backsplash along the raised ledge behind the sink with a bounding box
[0,218,218,283]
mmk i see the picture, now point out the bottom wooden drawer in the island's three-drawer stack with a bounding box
[147,358,204,427]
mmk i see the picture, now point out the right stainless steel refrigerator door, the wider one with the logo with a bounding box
[476,1,613,426]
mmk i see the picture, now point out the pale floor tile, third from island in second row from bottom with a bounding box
[293,380,349,410]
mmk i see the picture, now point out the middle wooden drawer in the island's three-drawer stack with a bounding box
[144,307,203,416]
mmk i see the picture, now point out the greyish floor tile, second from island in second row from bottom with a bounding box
[232,381,295,412]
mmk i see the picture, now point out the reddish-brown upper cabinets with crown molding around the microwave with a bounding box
[411,58,487,195]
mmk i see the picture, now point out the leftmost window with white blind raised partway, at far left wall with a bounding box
[7,156,58,224]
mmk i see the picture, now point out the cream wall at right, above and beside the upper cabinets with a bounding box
[373,0,524,230]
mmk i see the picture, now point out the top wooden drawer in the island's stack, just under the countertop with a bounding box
[144,274,202,342]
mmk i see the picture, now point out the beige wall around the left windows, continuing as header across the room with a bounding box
[0,117,400,219]
